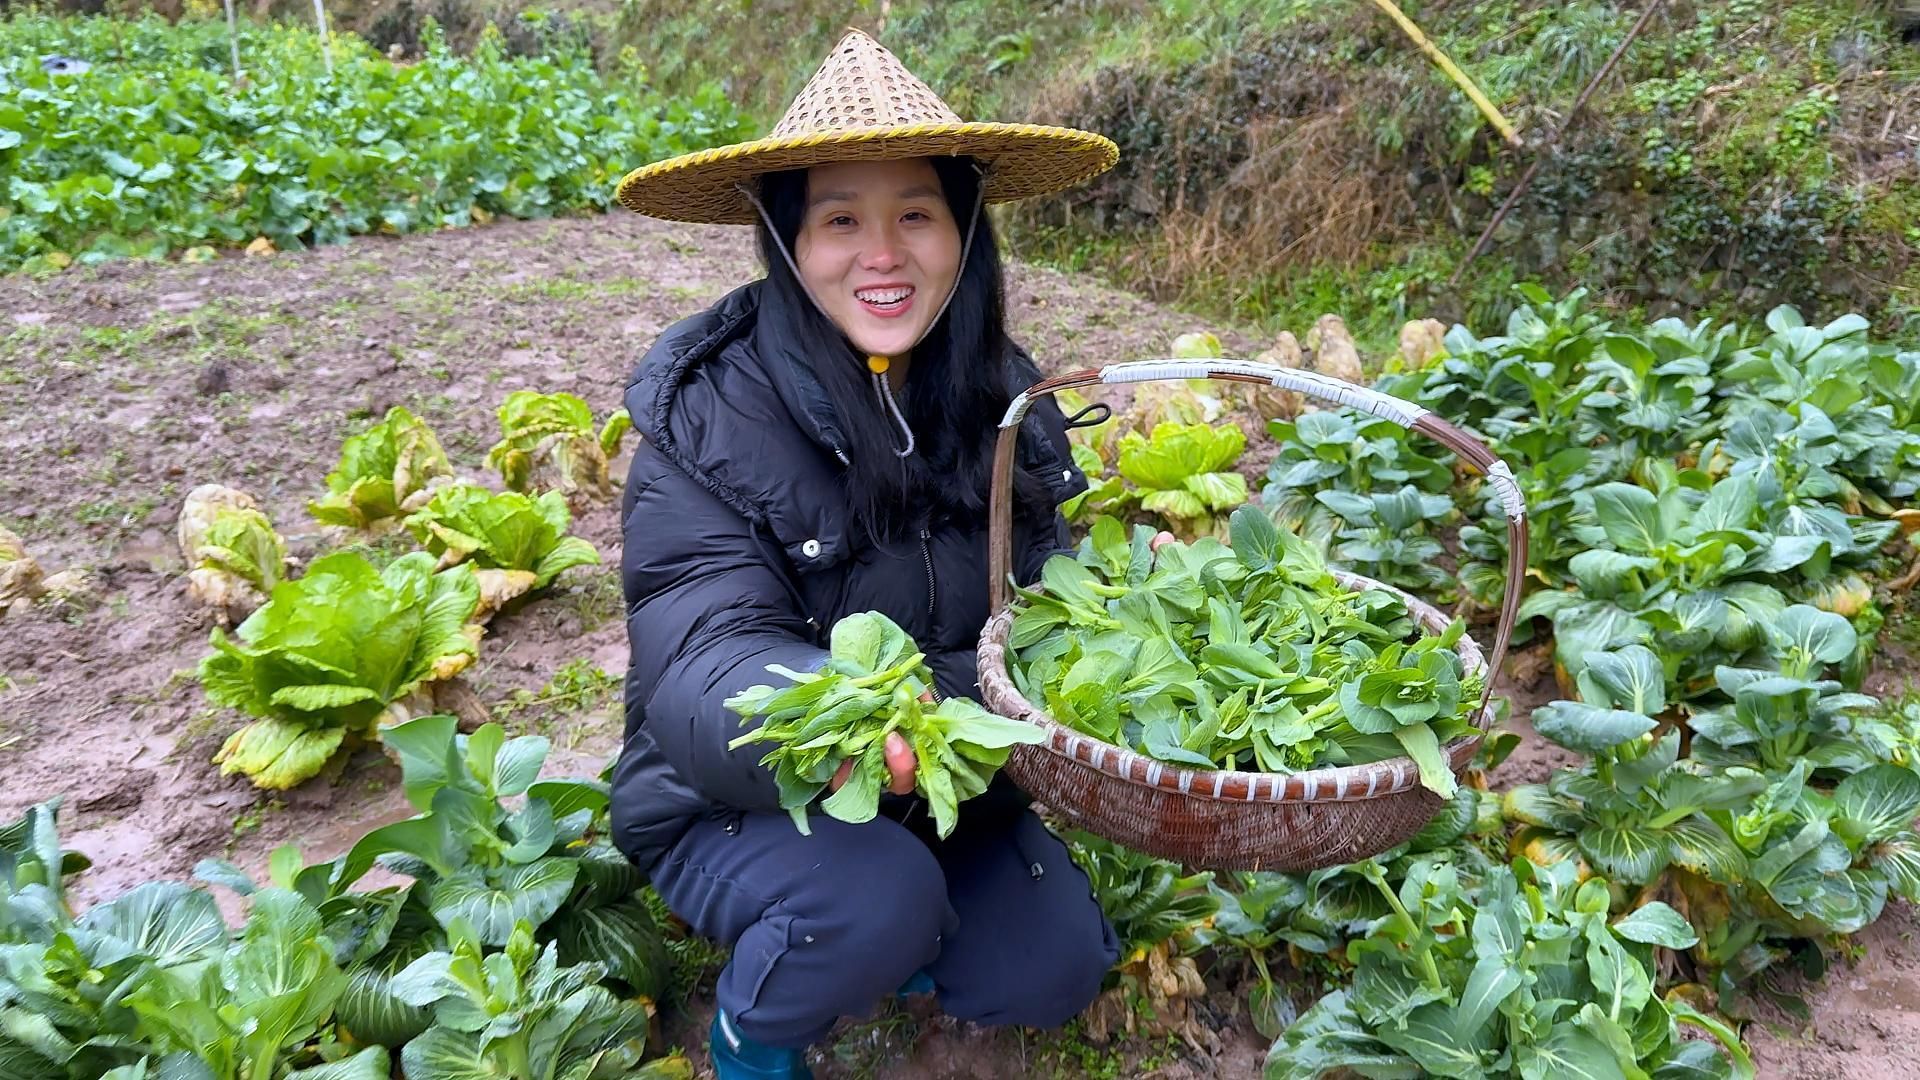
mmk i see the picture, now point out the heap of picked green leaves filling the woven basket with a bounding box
[1010,507,1482,796]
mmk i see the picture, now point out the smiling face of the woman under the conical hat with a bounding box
[793,160,960,357]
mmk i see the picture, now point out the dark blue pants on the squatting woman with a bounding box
[653,807,1119,1047]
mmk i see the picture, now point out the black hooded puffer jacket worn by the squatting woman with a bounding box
[612,282,1085,869]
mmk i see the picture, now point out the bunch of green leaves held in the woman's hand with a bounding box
[726,611,1044,836]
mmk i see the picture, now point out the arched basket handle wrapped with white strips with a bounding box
[987,359,1526,709]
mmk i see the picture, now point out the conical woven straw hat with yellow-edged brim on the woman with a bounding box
[620,31,1119,225]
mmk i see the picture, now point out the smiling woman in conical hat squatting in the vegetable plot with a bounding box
[612,33,1117,1080]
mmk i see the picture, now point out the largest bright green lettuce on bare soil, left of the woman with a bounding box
[200,552,480,788]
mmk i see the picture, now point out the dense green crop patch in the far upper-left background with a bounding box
[0,13,743,269]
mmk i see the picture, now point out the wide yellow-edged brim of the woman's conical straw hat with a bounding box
[618,123,1119,225]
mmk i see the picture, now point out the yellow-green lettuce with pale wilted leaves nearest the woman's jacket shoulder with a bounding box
[486,390,634,500]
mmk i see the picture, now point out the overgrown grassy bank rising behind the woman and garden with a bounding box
[616,0,1920,336]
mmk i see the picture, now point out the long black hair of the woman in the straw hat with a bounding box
[758,158,1054,540]
